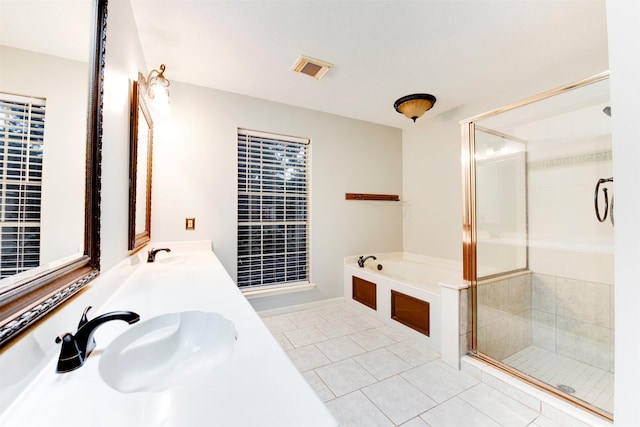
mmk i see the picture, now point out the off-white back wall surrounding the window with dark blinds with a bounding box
[151,83,403,310]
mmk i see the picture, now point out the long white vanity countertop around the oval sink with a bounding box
[0,247,337,427]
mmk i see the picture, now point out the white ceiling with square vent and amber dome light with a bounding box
[131,0,607,127]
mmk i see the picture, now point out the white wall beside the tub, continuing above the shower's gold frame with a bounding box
[402,68,608,261]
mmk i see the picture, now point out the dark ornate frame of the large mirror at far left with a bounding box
[0,0,107,348]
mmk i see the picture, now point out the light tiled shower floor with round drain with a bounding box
[502,346,613,413]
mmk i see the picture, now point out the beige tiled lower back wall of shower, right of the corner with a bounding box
[531,273,614,372]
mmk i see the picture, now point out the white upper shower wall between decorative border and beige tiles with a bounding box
[528,155,618,285]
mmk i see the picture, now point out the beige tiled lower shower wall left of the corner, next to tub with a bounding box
[477,273,532,360]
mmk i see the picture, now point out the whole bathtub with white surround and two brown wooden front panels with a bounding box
[343,252,468,369]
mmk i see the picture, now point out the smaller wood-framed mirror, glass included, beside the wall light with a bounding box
[128,81,153,253]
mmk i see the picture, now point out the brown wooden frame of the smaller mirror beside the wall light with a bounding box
[128,81,153,255]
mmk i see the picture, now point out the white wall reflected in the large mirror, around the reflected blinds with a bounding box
[0,46,89,264]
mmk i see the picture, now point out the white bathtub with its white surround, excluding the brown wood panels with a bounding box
[344,253,466,366]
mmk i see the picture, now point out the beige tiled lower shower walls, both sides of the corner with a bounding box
[477,273,614,372]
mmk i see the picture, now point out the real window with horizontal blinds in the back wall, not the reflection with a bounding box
[238,129,310,288]
